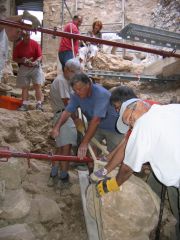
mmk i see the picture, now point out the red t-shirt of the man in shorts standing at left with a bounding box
[13,39,42,65]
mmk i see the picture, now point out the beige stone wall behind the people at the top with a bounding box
[43,0,158,64]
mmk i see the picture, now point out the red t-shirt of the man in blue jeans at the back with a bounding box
[59,22,80,56]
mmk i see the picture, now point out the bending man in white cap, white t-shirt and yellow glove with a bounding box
[97,98,180,196]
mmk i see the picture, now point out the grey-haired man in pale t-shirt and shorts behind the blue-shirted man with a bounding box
[48,59,81,186]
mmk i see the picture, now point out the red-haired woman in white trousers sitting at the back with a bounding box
[79,20,103,69]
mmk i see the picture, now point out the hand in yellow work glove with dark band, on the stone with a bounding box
[96,178,119,197]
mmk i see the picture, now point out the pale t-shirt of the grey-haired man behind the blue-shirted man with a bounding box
[50,75,73,113]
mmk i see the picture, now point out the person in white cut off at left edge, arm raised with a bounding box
[0,11,41,91]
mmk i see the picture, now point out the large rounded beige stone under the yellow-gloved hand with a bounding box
[87,176,159,240]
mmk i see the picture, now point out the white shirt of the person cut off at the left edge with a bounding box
[0,29,8,82]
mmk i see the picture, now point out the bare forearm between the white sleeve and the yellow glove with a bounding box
[116,163,133,186]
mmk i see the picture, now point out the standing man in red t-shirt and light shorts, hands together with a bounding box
[13,31,44,111]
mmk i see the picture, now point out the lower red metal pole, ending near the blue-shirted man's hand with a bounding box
[0,150,93,163]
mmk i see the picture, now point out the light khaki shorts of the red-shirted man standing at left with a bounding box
[16,65,45,88]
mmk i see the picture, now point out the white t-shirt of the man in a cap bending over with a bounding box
[124,104,180,187]
